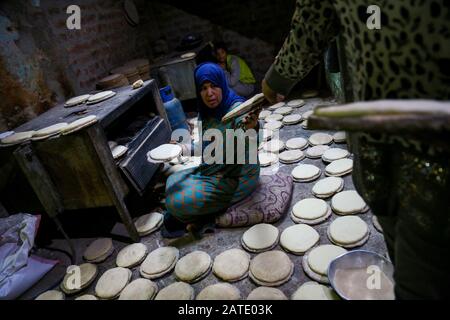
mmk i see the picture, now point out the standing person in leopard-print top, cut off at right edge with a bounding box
[262,0,450,299]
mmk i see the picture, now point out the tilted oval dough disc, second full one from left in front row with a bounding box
[95,267,132,300]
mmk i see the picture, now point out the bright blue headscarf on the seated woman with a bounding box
[194,62,245,120]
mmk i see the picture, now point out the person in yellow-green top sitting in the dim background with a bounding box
[214,42,256,98]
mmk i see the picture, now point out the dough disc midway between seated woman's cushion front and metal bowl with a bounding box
[280,224,320,255]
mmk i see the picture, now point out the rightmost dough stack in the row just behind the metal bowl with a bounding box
[327,216,369,248]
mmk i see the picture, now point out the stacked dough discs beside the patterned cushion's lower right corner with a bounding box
[291,198,331,225]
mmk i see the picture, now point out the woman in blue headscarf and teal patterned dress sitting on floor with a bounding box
[162,63,259,237]
